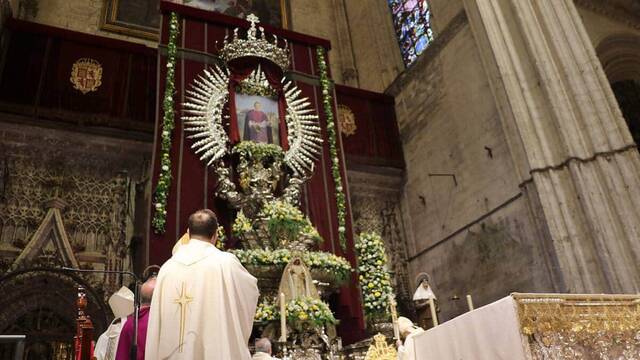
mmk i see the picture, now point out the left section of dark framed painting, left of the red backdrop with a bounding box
[101,0,160,40]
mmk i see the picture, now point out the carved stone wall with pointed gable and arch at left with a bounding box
[0,123,151,358]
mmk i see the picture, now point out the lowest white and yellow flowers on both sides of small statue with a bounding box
[253,297,337,327]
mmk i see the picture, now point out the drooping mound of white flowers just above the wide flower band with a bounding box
[258,200,322,243]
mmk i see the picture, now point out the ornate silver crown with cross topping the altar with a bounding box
[220,14,289,71]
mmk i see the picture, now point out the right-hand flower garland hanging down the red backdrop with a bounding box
[317,46,347,250]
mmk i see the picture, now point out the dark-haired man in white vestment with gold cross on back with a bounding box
[145,210,259,360]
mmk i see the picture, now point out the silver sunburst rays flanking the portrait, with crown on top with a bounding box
[182,16,322,178]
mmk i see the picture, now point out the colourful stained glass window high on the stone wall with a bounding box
[388,0,433,66]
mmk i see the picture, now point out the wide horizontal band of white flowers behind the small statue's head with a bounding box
[229,249,353,283]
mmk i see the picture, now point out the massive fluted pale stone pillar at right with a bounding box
[464,0,640,292]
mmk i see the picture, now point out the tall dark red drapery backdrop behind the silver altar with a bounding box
[148,1,364,344]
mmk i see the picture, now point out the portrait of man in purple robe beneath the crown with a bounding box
[235,93,280,145]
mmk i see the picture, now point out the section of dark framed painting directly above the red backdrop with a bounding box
[182,0,288,28]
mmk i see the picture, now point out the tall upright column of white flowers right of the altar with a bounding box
[356,233,393,322]
